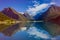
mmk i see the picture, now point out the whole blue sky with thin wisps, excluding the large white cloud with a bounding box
[0,0,60,12]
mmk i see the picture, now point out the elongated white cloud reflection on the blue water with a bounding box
[28,27,50,39]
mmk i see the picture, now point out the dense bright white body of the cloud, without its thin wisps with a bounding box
[27,4,48,16]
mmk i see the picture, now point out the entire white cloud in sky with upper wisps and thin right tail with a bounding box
[27,1,55,16]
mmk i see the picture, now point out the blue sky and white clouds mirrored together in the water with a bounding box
[0,23,60,40]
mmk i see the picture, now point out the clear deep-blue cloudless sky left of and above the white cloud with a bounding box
[0,0,50,12]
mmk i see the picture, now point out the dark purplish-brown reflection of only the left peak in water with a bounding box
[2,24,19,36]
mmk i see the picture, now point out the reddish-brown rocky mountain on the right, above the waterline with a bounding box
[44,5,60,25]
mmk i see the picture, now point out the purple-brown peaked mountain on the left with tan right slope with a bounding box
[1,7,27,21]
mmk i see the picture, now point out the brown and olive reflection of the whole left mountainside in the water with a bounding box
[0,22,30,36]
